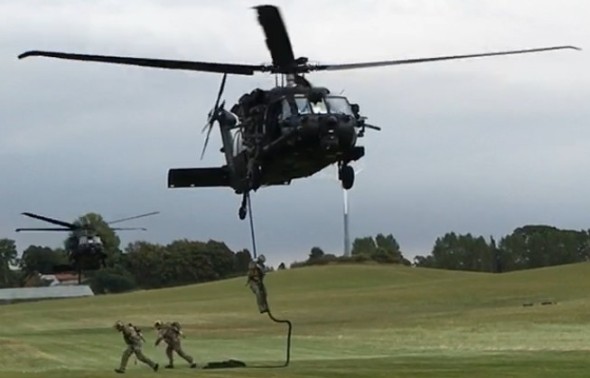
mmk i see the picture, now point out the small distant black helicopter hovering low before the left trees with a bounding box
[16,211,159,283]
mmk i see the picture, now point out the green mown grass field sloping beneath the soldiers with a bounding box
[0,264,590,377]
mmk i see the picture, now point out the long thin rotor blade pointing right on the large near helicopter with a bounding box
[309,46,581,71]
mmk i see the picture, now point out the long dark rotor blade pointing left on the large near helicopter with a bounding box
[18,50,269,75]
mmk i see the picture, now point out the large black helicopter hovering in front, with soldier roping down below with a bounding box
[19,5,579,219]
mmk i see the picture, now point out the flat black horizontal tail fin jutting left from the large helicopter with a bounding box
[168,167,231,188]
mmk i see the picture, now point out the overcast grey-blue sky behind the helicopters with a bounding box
[0,0,590,266]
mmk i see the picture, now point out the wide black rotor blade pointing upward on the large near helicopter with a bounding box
[254,5,295,72]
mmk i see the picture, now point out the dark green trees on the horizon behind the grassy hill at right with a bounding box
[291,225,590,273]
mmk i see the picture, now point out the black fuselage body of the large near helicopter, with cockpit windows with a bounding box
[227,87,364,193]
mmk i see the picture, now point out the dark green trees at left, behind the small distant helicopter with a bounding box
[0,213,252,294]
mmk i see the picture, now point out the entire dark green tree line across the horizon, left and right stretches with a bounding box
[0,213,590,294]
